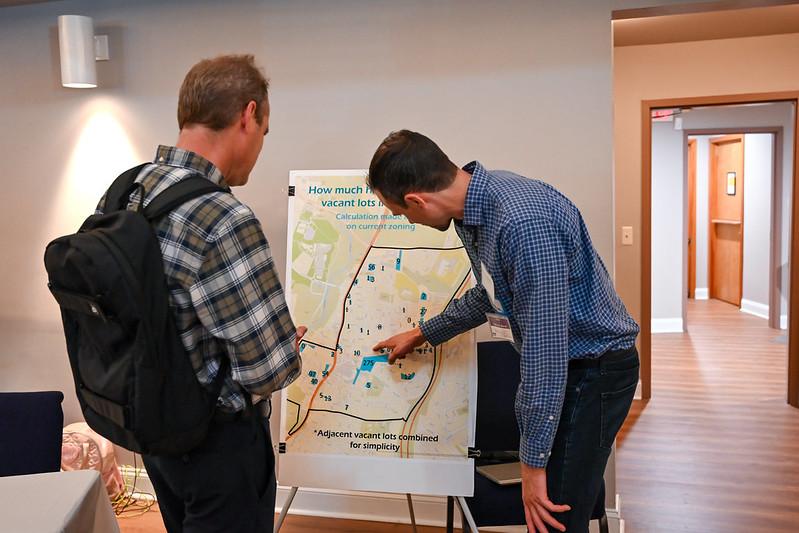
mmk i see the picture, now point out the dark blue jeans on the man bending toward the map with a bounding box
[547,347,640,533]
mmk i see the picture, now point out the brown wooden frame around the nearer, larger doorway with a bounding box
[639,91,799,408]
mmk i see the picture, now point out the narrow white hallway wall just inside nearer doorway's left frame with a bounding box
[652,118,684,333]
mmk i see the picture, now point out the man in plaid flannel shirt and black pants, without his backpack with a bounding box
[101,56,305,533]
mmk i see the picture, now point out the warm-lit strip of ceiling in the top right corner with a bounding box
[613,4,799,46]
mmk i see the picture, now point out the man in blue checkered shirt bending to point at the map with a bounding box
[368,130,639,532]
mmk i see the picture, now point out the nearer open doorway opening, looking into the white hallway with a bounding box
[651,102,793,333]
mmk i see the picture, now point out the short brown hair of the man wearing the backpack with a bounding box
[178,54,269,131]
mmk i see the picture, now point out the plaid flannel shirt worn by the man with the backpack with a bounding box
[98,146,301,412]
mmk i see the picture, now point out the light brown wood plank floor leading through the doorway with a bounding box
[115,300,799,533]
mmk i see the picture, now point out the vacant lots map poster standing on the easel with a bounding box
[281,171,476,459]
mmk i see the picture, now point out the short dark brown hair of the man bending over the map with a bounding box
[366,130,458,206]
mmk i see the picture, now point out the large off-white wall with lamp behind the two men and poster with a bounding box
[0,0,614,520]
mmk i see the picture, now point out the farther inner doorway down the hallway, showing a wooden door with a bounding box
[684,128,792,330]
